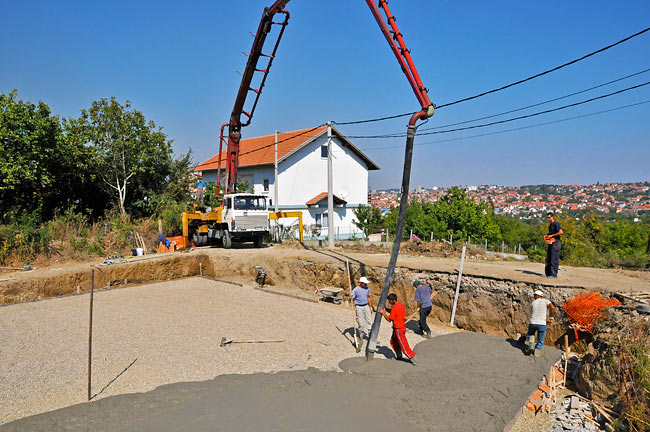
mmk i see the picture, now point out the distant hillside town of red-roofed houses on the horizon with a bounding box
[368,181,650,219]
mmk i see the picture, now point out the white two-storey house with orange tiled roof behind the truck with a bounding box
[194,126,379,239]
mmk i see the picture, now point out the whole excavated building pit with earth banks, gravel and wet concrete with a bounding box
[0,244,650,431]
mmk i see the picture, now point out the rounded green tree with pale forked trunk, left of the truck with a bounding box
[67,97,172,215]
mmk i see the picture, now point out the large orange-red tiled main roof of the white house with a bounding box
[194,126,327,171]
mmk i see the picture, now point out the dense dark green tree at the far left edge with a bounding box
[0,90,102,222]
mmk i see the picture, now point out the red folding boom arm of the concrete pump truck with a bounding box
[217,0,435,195]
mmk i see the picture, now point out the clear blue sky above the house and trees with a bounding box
[0,0,650,189]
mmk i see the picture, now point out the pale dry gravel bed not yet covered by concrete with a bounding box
[0,278,446,424]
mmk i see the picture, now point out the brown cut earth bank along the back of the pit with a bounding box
[0,249,585,346]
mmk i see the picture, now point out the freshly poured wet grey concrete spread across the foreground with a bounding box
[3,333,560,431]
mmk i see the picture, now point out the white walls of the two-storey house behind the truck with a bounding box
[197,134,368,239]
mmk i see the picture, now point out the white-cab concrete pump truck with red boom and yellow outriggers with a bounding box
[182,0,434,248]
